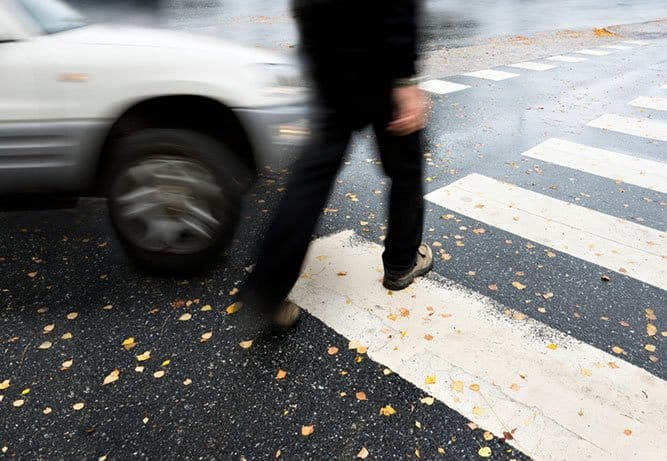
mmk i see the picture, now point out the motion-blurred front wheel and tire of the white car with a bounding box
[107,129,247,273]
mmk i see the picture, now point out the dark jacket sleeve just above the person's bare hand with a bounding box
[382,0,419,79]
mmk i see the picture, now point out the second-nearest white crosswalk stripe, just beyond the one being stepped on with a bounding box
[426,174,667,290]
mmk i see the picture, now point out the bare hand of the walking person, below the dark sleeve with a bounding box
[387,85,428,136]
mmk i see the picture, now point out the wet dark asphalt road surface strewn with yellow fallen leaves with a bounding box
[0,3,667,460]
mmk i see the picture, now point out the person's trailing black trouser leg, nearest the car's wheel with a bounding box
[241,119,351,313]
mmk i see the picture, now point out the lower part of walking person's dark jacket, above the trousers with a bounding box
[293,0,418,127]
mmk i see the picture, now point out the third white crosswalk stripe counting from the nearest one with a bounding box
[523,139,667,194]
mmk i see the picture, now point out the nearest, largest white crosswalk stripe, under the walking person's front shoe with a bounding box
[290,232,667,461]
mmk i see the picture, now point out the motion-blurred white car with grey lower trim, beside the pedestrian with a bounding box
[0,0,308,270]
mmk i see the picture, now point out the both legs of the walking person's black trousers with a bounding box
[241,104,424,313]
